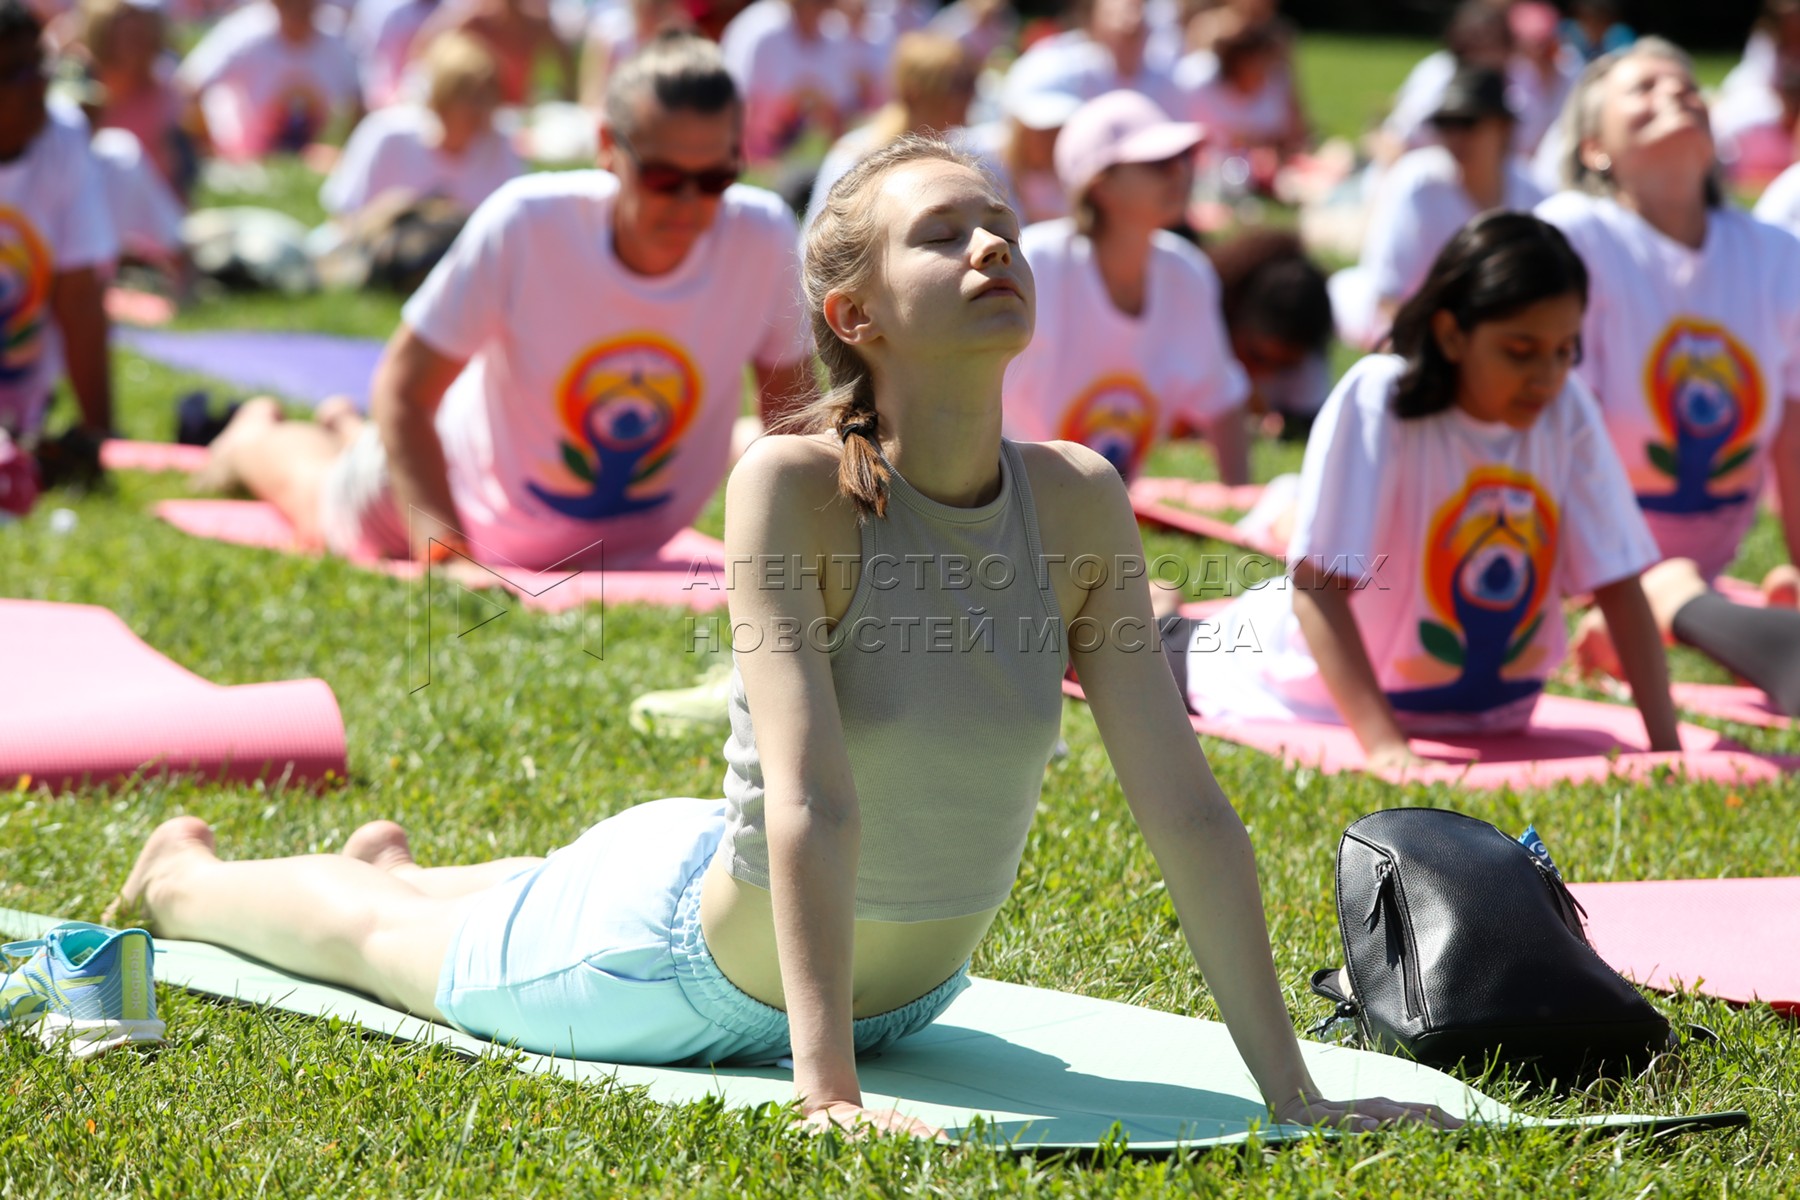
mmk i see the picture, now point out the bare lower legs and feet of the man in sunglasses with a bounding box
[194,396,360,545]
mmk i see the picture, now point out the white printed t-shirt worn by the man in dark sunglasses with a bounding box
[403,171,810,567]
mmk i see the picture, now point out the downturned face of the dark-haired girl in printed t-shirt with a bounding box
[1431,293,1582,430]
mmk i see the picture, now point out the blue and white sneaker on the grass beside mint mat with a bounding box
[0,921,164,1058]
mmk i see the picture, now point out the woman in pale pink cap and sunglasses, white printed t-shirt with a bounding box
[1006,92,1249,484]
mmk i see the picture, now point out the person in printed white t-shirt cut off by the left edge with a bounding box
[0,0,119,461]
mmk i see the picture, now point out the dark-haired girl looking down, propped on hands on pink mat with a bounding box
[1159,212,1681,768]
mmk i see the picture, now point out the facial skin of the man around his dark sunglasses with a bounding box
[599,103,743,275]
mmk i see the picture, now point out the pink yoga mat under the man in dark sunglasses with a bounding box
[155,500,725,612]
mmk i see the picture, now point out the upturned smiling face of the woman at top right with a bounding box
[1582,54,1714,187]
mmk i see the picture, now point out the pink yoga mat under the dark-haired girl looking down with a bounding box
[1062,680,1789,790]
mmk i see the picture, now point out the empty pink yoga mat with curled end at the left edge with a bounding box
[0,599,346,788]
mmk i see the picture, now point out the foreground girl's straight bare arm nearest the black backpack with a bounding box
[1046,448,1451,1128]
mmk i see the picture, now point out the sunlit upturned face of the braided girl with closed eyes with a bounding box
[842,160,1037,367]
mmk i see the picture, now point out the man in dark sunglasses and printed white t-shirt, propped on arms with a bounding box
[189,32,812,569]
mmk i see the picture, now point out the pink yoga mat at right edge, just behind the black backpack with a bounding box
[1570,878,1800,1016]
